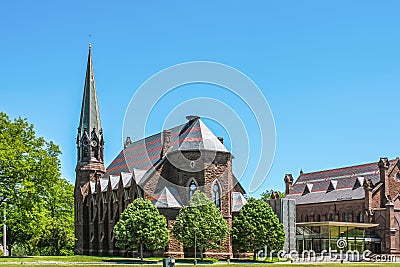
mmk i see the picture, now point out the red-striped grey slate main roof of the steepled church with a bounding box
[105,117,229,177]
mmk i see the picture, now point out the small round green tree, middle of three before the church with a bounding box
[172,190,229,259]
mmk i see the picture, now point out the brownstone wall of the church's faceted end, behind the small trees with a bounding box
[144,151,233,258]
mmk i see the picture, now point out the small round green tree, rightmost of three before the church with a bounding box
[232,199,285,260]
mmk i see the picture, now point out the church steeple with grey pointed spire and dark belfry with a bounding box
[76,44,104,162]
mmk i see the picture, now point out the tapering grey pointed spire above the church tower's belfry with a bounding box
[79,44,101,134]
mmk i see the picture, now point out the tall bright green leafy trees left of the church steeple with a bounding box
[0,112,73,254]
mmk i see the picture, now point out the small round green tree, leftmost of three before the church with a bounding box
[114,198,169,261]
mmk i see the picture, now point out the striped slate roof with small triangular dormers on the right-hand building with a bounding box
[286,160,395,204]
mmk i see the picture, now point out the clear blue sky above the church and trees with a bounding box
[0,0,400,197]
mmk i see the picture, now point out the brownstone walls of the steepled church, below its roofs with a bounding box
[75,151,239,258]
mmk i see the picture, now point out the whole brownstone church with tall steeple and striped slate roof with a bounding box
[75,46,246,258]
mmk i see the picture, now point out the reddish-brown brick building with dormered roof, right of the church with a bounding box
[284,158,400,254]
